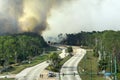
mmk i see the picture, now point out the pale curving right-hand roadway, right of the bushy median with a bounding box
[60,48,86,80]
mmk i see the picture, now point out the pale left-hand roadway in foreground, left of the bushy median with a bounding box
[16,61,49,80]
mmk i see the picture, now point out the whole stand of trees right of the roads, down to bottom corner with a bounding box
[61,30,120,79]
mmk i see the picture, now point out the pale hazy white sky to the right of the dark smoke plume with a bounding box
[43,0,120,36]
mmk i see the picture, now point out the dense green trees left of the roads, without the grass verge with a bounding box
[0,33,48,67]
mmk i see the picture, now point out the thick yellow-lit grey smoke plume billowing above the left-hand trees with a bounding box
[0,0,71,34]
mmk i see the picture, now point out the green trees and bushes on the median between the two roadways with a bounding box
[47,47,73,72]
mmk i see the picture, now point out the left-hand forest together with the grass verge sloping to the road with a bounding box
[0,33,56,74]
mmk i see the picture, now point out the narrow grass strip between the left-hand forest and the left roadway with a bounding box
[2,54,48,74]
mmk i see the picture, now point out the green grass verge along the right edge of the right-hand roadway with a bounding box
[78,51,105,80]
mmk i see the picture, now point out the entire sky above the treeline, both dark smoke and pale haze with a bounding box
[0,0,120,38]
